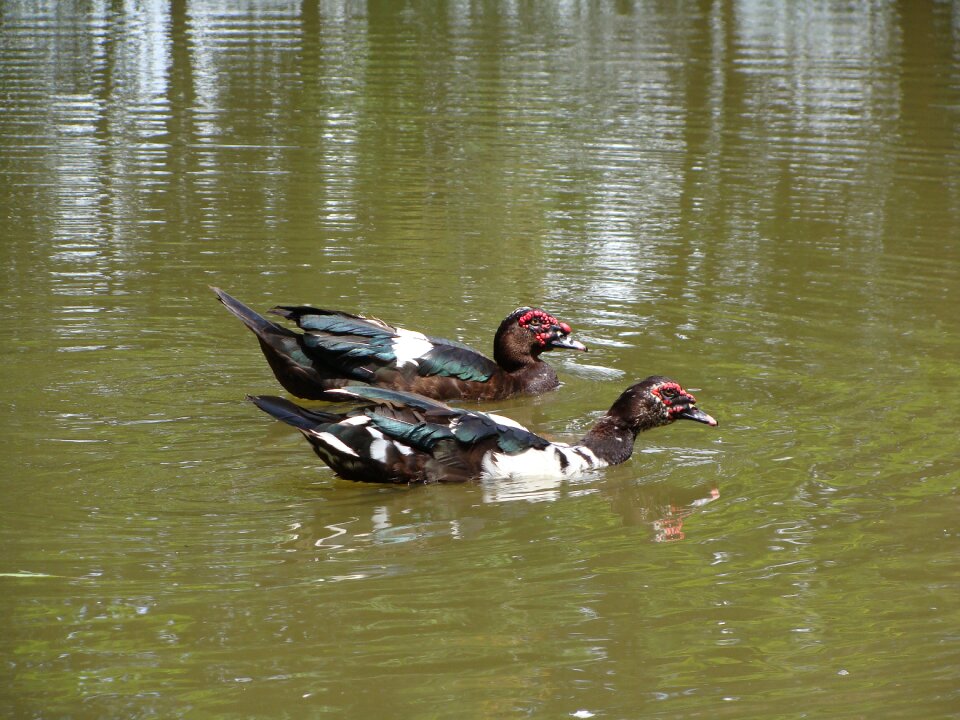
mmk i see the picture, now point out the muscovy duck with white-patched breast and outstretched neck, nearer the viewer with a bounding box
[249,376,717,483]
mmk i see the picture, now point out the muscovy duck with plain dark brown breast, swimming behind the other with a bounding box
[212,288,587,400]
